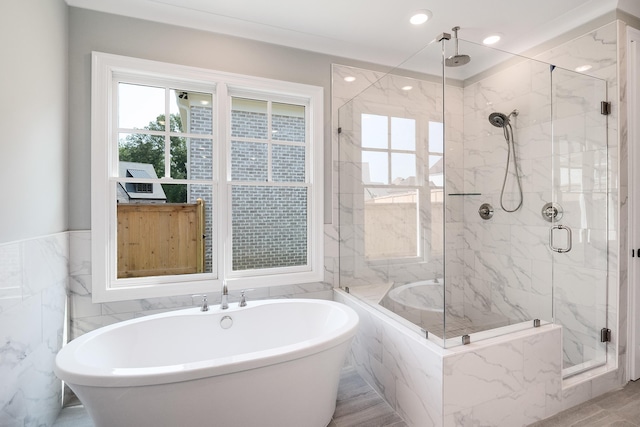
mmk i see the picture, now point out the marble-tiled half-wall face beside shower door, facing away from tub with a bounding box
[443,325,562,427]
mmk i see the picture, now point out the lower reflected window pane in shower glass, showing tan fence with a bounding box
[364,188,419,259]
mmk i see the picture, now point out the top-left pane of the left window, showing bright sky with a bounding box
[118,83,165,130]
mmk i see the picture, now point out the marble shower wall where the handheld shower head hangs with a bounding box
[460,23,618,367]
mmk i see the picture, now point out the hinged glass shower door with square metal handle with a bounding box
[552,66,609,377]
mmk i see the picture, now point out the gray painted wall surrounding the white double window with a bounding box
[69,8,396,230]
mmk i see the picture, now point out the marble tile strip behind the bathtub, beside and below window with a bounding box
[69,231,333,339]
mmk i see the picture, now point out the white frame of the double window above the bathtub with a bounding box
[91,52,324,302]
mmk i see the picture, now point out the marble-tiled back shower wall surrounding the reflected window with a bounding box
[332,65,463,304]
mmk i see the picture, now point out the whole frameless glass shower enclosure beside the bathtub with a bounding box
[334,33,609,375]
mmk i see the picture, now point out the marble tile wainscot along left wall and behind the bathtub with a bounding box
[0,231,333,427]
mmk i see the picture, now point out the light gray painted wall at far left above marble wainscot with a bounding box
[0,0,68,243]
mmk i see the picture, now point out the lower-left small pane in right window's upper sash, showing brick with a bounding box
[231,141,268,182]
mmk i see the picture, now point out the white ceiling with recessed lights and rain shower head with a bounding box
[66,0,640,66]
